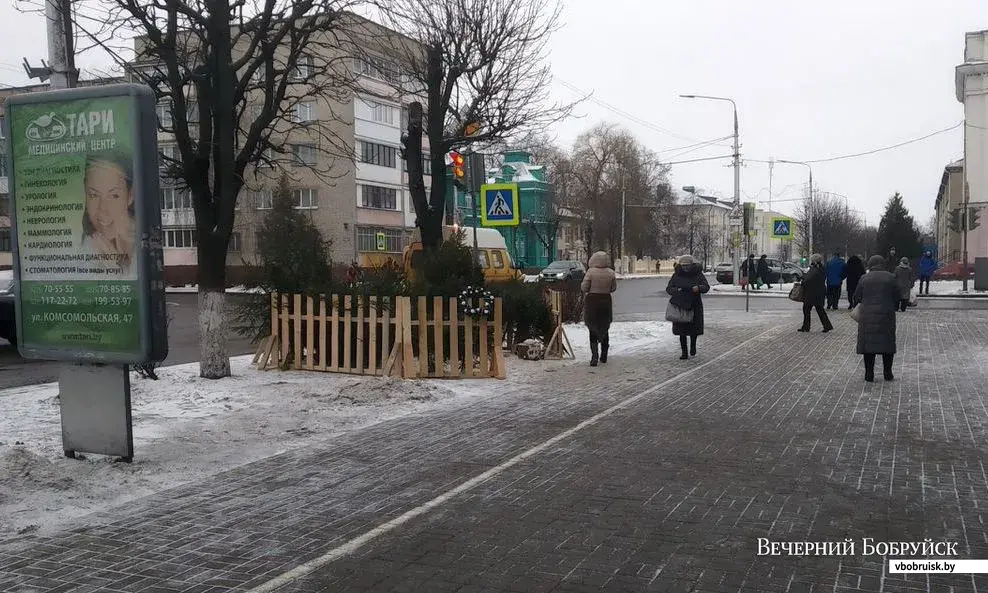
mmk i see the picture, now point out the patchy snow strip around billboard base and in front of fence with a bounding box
[0,321,669,537]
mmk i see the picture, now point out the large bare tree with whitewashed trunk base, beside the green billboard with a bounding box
[75,0,358,378]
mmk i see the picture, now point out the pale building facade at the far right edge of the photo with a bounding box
[956,30,988,261]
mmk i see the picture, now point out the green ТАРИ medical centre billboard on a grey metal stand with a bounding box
[4,84,168,461]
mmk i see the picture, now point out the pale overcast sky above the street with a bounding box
[0,0,988,224]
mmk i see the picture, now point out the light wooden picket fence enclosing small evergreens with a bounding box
[254,294,506,379]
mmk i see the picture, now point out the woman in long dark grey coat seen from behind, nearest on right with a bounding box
[854,255,902,383]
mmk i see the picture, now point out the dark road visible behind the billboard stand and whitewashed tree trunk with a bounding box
[0,294,253,389]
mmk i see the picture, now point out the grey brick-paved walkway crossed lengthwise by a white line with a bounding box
[0,310,988,593]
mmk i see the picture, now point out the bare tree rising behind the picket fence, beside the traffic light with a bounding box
[379,0,572,250]
